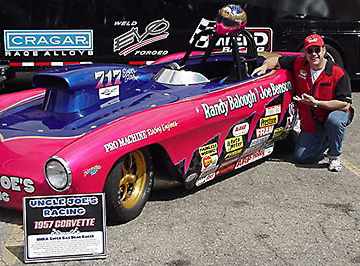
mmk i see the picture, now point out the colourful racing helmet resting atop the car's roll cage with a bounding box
[215,5,247,35]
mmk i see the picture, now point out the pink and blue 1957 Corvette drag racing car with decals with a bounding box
[0,5,297,222]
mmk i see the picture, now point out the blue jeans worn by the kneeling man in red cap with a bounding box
[294,110,351,163]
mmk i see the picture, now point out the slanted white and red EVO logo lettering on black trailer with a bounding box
[113,18,170,56]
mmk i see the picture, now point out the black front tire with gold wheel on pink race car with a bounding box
[104,149,153,223]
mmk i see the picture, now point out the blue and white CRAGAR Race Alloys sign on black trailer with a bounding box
[4,30,93,56]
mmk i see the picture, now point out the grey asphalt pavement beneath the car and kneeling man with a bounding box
[0,78,360,266]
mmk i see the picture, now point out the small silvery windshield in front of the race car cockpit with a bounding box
[154,68,210,85]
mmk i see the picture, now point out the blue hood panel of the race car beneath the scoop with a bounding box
[0,91,178,139]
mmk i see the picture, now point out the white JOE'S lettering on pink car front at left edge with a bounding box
[0,175,35,202]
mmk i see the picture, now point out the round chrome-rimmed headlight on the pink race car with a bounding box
[45,156,72,192]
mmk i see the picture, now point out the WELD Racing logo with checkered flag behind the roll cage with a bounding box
[190,18,273,52]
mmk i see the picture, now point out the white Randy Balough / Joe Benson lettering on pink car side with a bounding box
[200,81,292,119]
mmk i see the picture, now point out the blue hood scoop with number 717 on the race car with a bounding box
[32,64,152,113]
